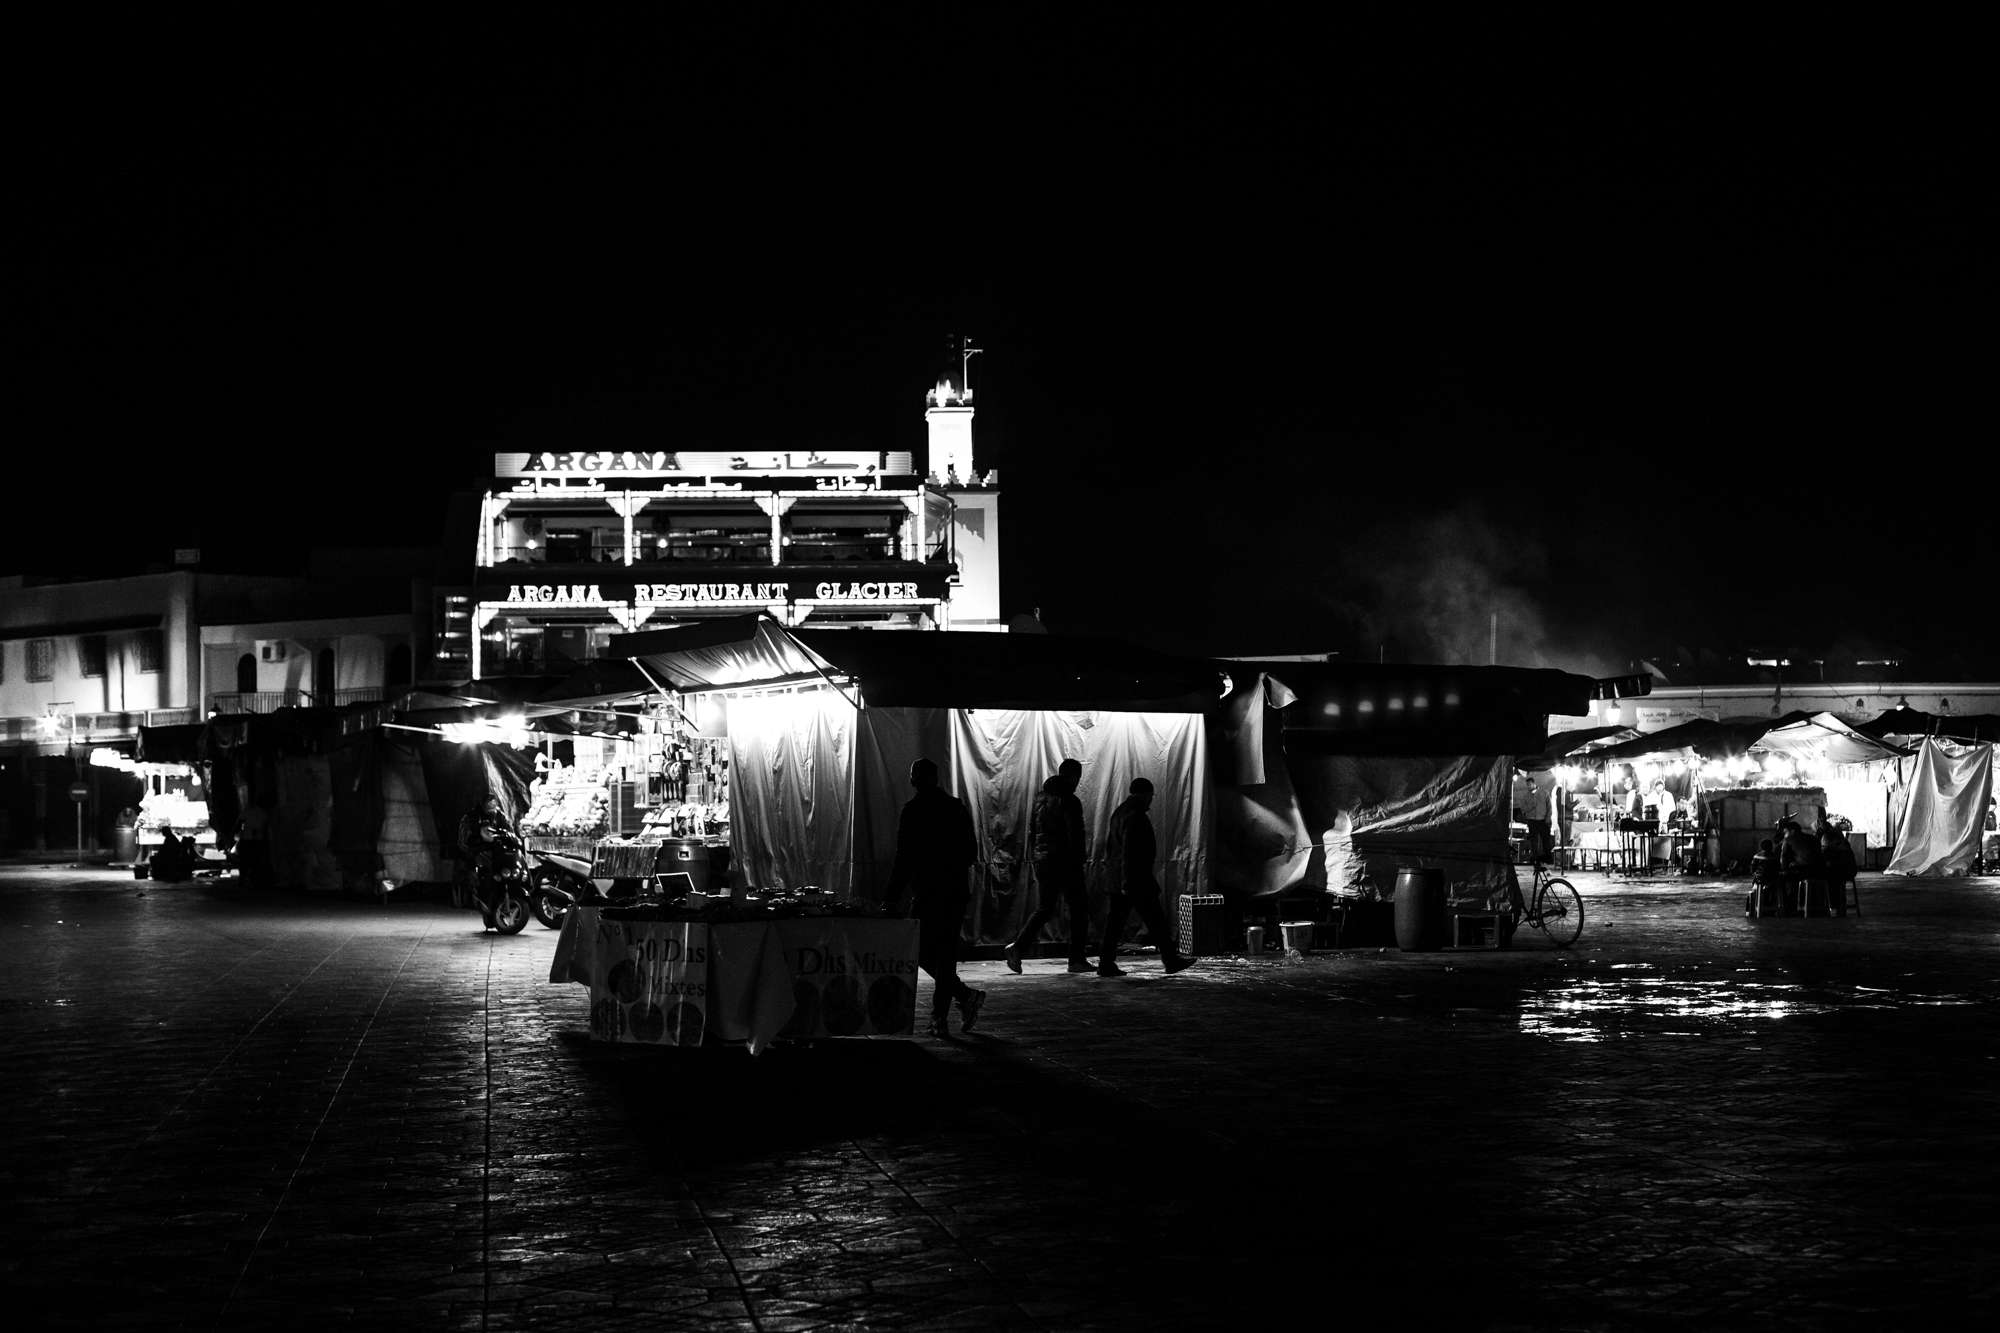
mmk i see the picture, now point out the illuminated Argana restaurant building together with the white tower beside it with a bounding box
[442,348,1004,681]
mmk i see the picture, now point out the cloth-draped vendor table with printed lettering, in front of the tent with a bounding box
[548,907,918,1053]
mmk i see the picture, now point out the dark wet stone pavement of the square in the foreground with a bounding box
[0,865,2000,1333]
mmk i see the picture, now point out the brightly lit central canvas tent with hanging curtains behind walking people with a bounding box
[610,614,1220,945]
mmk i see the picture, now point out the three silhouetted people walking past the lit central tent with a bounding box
[888,759,1194,1037]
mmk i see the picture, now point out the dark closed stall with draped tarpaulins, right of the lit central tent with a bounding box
[1210,662,1596,899]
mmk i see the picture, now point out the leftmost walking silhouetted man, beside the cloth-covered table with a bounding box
[888,759,986,1037]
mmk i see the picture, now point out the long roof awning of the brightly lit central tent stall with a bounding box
[610,614,1222,713]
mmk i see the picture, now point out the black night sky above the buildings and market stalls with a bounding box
[11,6,1996,673]
